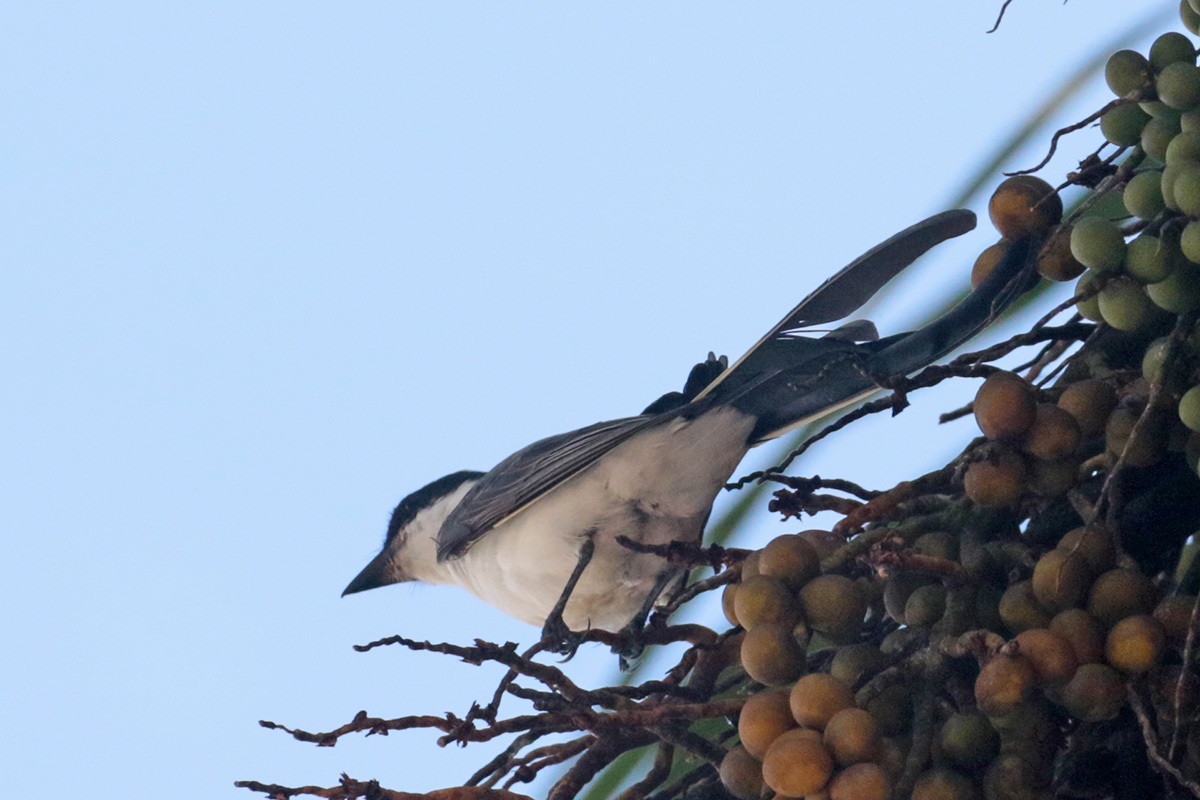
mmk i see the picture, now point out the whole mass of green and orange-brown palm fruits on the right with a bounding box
[720,10,1200,800]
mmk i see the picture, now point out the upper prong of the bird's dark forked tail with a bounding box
[700,209,976,397]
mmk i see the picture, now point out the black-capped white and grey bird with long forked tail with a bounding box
[342,209,1037,652]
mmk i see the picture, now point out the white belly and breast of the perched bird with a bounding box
[440,408,755,631]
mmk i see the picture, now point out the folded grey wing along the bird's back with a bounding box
[438,413,676,561]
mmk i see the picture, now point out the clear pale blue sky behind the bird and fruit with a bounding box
[0,0,1178,799]
